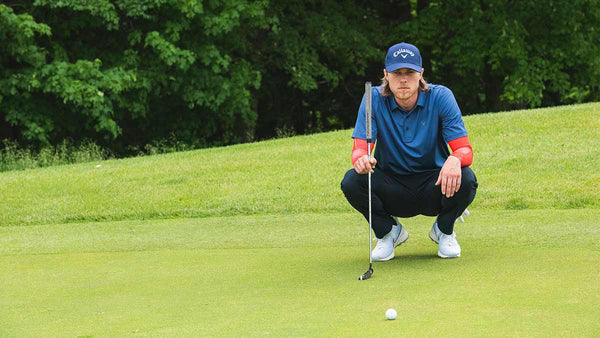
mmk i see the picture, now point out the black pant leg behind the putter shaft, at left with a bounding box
[341,168,417,238]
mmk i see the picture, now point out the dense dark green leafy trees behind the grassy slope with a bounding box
[0,0,600,156]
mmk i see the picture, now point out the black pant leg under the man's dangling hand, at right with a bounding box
[421,167,478,234]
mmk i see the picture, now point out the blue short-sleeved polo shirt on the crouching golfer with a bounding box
[352,84,467,175]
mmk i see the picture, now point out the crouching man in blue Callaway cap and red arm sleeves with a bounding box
[341,42,477,261]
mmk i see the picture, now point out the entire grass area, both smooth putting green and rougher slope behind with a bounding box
[0,104,600,337]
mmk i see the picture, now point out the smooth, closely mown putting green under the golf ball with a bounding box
[0,209,600,337]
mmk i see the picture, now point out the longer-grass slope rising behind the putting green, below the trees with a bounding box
[0,104,600,226]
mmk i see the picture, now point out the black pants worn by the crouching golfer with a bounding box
[342,167,477,238]
